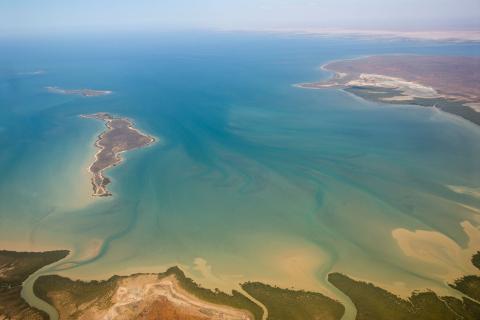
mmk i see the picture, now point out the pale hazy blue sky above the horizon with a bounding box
[0,0,480,34]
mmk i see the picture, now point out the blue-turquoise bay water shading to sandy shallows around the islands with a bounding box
[0,33,480,310]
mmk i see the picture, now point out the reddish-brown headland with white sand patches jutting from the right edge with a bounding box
[296,55,480,125]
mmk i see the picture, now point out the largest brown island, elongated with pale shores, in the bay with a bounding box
[81,112,155,197]
